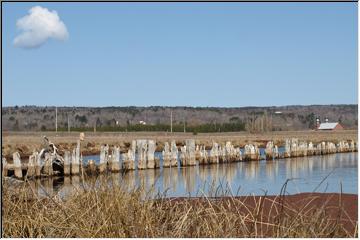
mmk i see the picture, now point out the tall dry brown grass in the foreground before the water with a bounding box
[2,176,357,238]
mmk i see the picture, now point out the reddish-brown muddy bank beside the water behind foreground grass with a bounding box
[166,192,358,237]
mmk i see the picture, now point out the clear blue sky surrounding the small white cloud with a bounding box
[2,2,358,107]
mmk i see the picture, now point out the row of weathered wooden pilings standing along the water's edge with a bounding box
[2,138,357,178]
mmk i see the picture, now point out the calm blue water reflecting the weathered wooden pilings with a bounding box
[32,153,358,196]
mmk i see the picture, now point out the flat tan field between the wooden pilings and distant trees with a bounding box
[2,130,357,157]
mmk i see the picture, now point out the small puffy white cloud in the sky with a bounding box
[14,6,69,48]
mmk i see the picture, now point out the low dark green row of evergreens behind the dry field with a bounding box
[54,122,246,134]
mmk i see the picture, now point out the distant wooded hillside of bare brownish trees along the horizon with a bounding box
[2,104,358,131]
